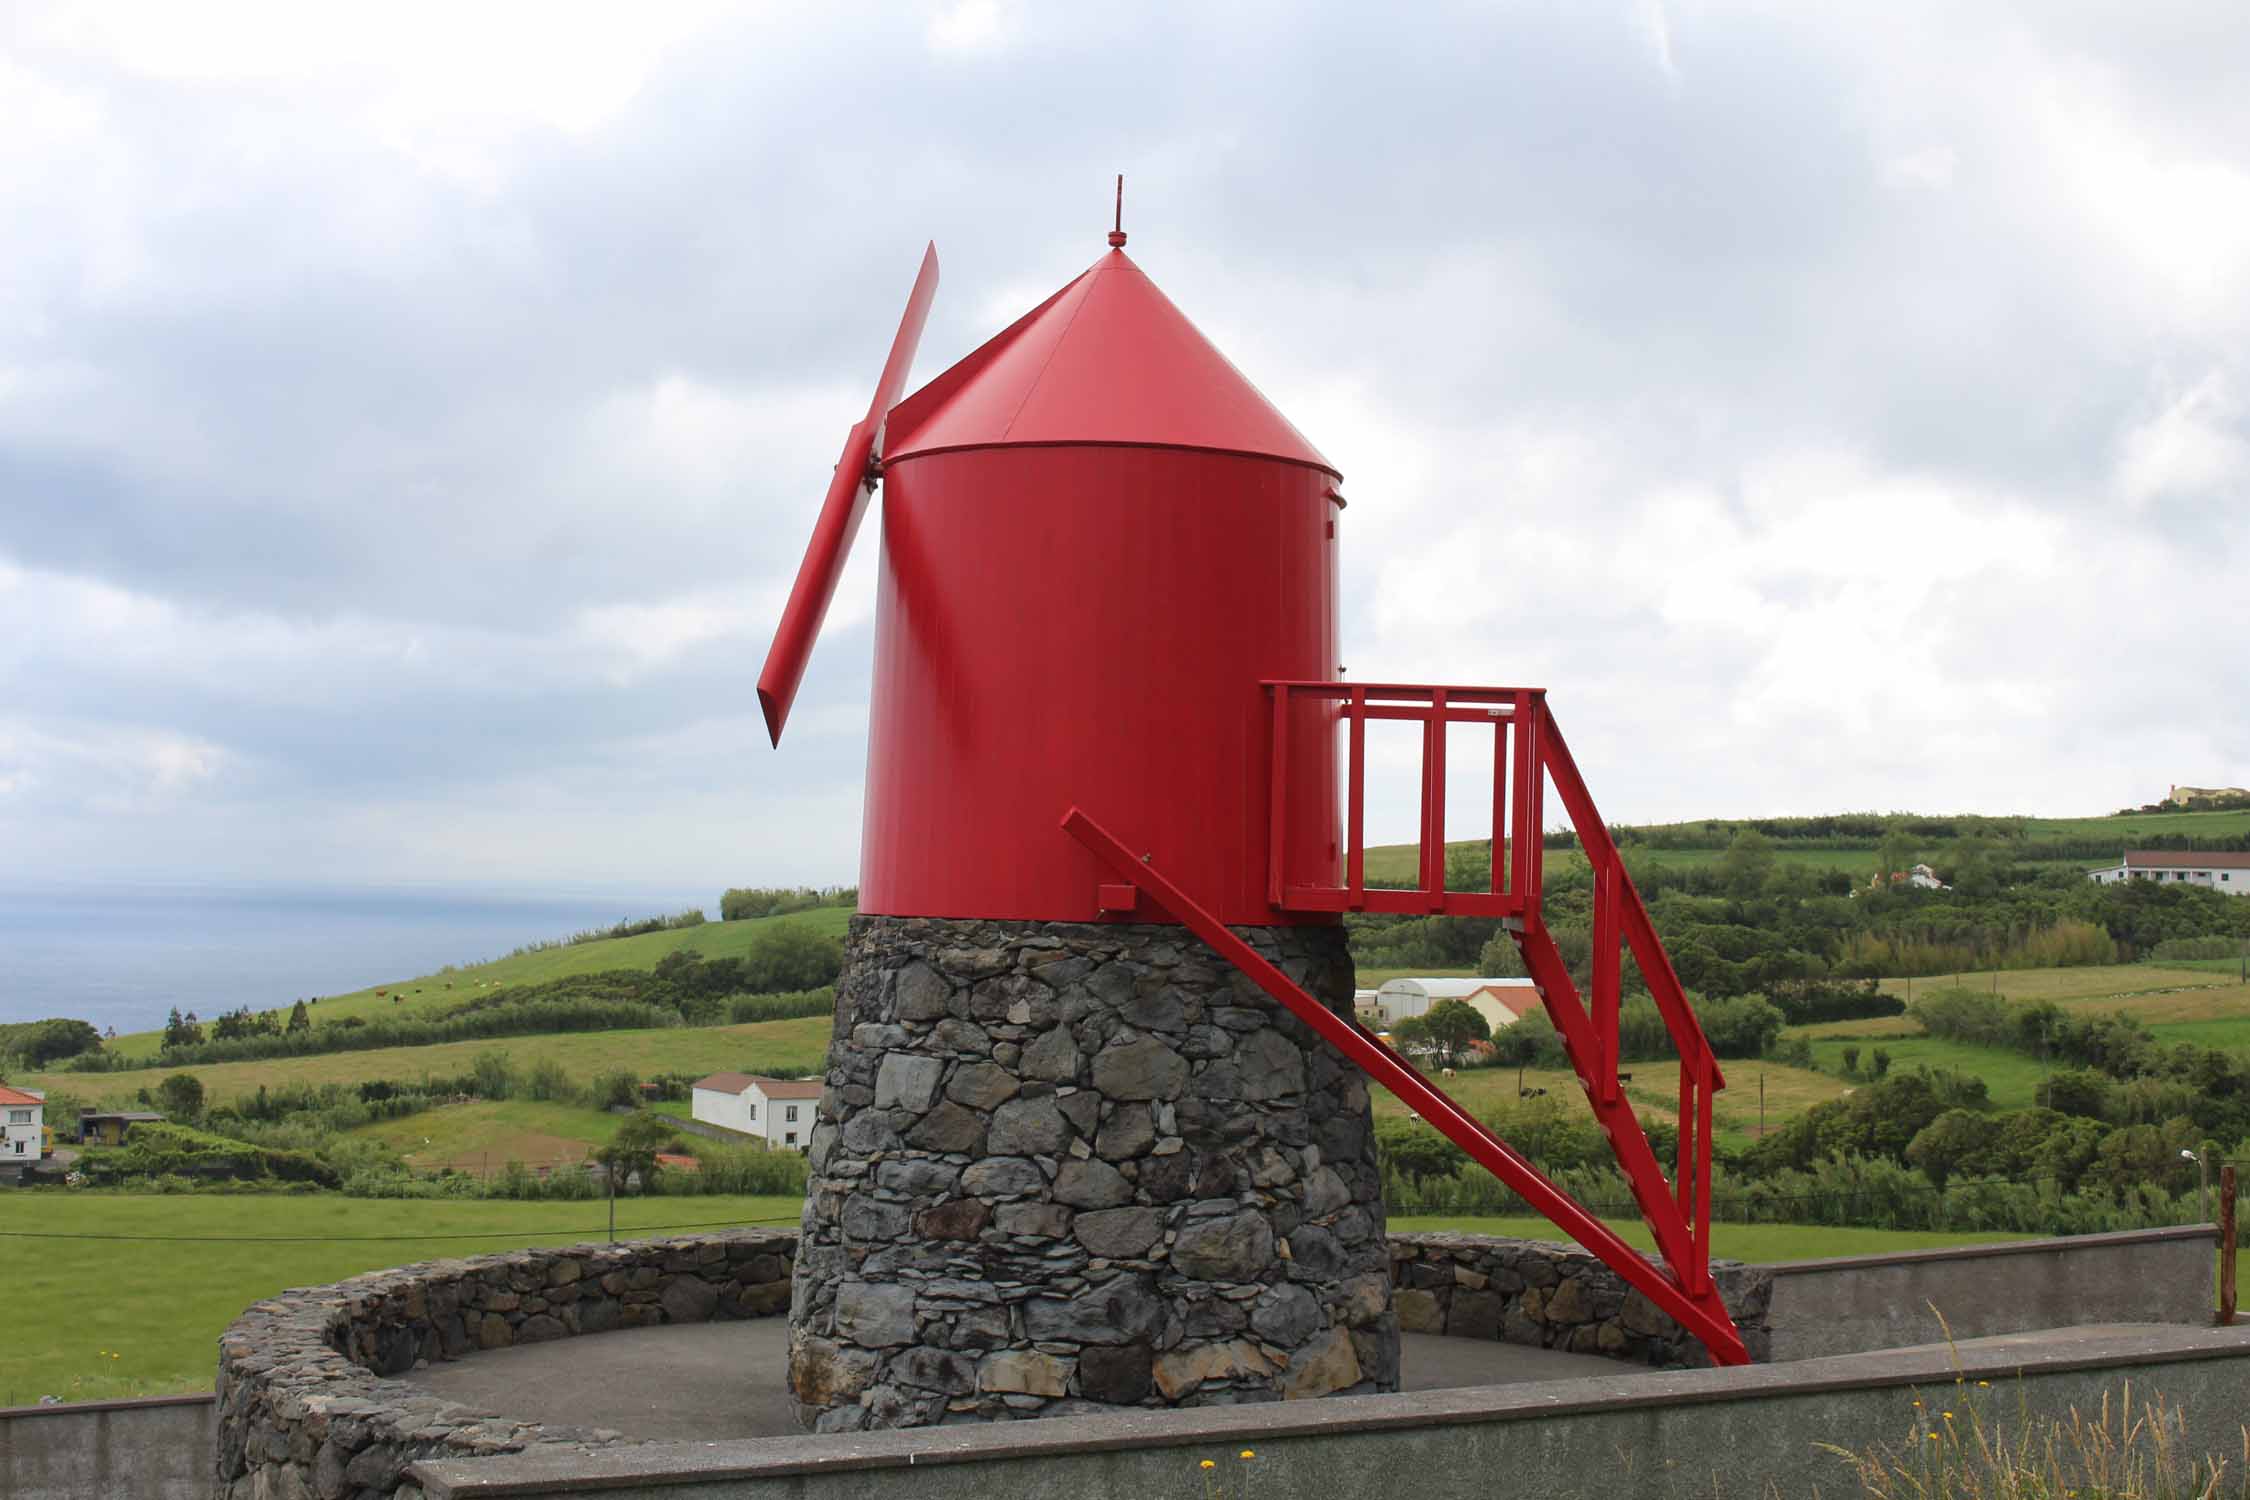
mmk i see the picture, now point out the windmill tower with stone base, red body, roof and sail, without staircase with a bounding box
[783,234,1397,1430]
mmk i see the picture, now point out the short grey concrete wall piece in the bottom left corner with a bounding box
[0,1397,216,1500]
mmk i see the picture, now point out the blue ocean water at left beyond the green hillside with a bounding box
[0,884,718,1032]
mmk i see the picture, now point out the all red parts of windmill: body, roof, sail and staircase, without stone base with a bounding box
[758,196,1748,1363]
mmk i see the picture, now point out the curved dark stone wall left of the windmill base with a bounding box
[212,1230,797,1500]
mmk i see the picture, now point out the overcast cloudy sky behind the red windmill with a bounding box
[0,0,2250,888]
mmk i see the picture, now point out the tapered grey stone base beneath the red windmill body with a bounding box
[790,915,1400,1433]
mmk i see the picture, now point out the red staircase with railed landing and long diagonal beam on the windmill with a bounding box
[1062,681,1751,1365]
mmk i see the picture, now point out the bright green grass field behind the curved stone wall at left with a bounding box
[0,1190,801,1406]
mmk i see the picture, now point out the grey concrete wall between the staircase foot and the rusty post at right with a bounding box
[1766,1223,2216,1361]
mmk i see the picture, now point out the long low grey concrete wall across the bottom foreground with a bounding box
[412,1329,2250,1500]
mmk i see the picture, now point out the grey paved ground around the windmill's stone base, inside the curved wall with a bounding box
[405,1318,1634,1442]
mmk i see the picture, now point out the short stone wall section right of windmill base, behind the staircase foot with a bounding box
[1391,1235,1773,1365]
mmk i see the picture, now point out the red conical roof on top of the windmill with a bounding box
[882,250,1341,479]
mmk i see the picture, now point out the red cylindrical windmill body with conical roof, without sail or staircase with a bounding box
[860,250,1343,924]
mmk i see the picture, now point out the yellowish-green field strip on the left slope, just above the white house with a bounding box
[23,1016,830,1104]
